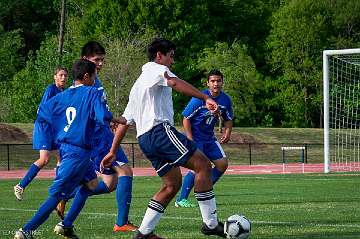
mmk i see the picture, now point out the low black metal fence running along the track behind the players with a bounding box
[0,143,323,170]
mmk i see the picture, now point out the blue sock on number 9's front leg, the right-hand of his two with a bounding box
[63,186,92,227]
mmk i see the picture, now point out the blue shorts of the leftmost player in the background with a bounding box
[33,121,58,151]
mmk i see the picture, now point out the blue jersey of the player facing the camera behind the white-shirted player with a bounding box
[182,89,233,142]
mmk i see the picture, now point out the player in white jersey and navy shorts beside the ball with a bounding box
[102,39,225,239]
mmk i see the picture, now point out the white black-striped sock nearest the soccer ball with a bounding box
[195,190,218,229]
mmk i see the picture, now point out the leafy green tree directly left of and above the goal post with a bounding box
[265,0,360,127]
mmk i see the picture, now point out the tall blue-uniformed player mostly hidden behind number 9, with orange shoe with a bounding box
[58,41,137,232]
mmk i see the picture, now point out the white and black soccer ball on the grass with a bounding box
[224,214,251,239]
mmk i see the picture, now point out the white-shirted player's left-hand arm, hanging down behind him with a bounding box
[100,124,129,169]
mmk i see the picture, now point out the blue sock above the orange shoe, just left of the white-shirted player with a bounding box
[116,176,132,226]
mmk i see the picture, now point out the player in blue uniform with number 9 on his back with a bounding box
[15,60,112,239]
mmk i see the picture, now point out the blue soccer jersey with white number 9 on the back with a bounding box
[38,85,112,149]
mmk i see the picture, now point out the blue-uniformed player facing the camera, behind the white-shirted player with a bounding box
[175,69,233,207]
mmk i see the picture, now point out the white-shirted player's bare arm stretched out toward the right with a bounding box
[164,72,218,113]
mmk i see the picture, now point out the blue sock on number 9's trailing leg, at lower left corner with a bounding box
[23,196,60,231]
